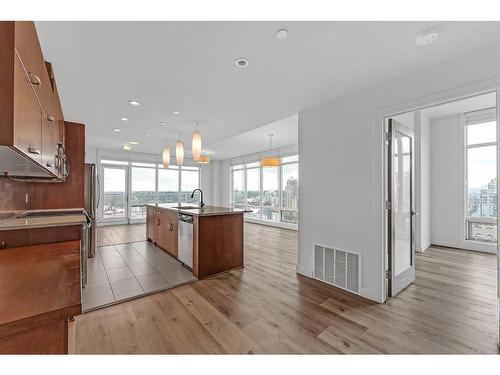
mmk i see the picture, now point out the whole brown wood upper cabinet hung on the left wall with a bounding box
[0,21,64,178]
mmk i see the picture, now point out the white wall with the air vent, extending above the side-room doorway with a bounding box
[297,45,500,302]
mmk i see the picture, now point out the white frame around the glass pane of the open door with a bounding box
[386,118,416,297]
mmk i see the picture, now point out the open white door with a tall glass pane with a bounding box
[386,119,415,297]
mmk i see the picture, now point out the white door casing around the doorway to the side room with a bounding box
[373,77,500,347]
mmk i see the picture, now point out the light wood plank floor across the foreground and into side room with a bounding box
[70,223,497,354]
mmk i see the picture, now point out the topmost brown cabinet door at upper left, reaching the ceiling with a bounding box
[14,21,43,97]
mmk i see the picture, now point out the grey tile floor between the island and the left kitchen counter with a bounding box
[82,241,196,311]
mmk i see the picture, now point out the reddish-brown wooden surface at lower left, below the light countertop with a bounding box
[0,241,81,337]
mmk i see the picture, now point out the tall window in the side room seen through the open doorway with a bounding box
[465,109,497,243]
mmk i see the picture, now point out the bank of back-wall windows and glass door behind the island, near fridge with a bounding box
[100,160,200,221]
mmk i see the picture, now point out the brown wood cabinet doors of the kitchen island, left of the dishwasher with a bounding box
[146,206,178,258]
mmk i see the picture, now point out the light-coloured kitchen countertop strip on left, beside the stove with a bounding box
[0,208,87,231]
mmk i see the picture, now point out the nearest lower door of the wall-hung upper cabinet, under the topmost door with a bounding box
[14,51,42,163]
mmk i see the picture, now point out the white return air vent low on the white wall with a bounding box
[314,245,361,294]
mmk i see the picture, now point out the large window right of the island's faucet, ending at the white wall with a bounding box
[231,155,299,224]
